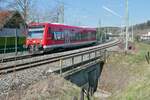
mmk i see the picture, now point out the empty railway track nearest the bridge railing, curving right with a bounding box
[0,40,119,74]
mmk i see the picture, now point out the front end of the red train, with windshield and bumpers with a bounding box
[26,25,45,54]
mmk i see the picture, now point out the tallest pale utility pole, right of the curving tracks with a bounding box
[125,0,129,51]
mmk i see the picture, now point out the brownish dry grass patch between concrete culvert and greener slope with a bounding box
[100,54,134,93]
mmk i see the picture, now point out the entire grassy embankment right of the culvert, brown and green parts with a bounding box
[100,43,150,100]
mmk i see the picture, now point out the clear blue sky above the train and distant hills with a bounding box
[32,0,150,27]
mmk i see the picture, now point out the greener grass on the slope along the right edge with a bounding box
[109,43,150,100]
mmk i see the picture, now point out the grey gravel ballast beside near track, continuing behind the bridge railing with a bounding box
[0,52,94,95]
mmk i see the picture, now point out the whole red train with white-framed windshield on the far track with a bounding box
[26,23,96,52]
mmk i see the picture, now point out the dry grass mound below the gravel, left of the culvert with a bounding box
[1,76,80,100]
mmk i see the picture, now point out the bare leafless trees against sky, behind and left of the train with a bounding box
[0,0,61,23]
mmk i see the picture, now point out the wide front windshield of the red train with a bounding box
[28,26,44,38]
